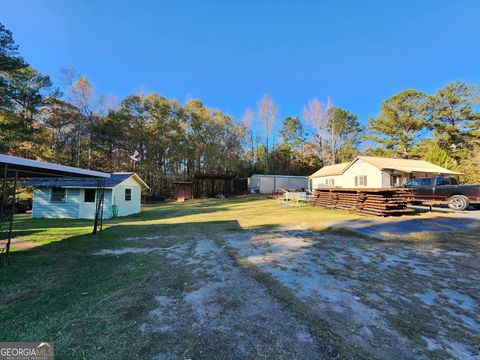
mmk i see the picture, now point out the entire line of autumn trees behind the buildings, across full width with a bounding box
[0,24,480,196]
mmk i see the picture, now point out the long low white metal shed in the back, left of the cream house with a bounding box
[248,174,308,194]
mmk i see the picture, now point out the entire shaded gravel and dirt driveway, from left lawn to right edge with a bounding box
[94,228,480,359]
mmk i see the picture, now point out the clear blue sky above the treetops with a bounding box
[0,0,480,126]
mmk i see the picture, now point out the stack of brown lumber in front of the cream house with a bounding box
[315,188,414,216]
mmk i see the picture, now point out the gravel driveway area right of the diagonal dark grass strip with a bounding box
[225,229,480,359]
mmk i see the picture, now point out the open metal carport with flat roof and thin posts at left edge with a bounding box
[0,154,110,265]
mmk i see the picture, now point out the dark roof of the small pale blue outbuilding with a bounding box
[22,173,133,188]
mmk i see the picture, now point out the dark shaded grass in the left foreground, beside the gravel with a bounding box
[0,221,255,359]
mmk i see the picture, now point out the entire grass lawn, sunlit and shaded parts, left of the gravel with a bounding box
[0,197,356,359]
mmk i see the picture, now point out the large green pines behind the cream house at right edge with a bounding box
[365,81,480,182]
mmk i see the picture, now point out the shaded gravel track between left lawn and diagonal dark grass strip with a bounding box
[95,235,323,359]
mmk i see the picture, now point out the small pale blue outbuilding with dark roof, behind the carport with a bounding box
[22,173,148,219]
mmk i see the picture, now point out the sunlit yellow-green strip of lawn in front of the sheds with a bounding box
[8,196,359,250]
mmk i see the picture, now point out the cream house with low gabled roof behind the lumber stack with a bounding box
[309,156,461,189]
